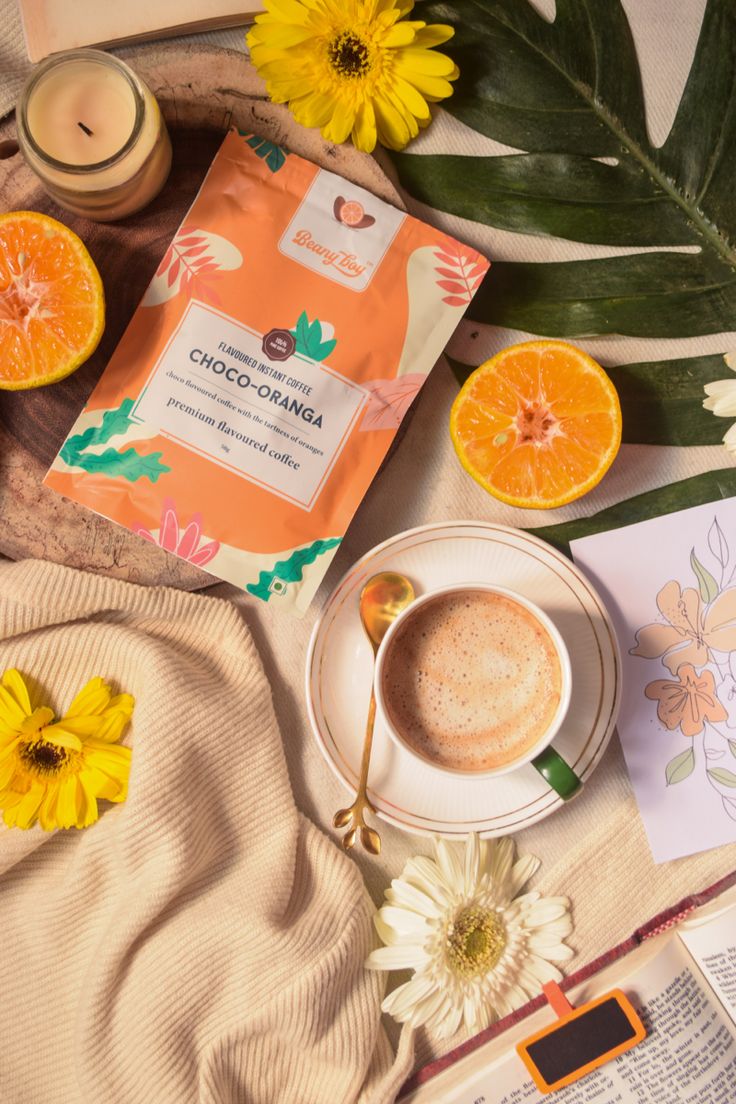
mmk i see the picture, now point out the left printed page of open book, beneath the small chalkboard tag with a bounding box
[405,940,736,1104]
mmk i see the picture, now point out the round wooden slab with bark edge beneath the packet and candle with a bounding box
[0,45,403,590]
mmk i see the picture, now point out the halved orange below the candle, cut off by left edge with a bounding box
[0,211,105,391]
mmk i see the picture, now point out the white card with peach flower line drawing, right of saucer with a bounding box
[570,498,736,862]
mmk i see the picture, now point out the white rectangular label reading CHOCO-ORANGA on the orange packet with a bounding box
[132,300,366,510]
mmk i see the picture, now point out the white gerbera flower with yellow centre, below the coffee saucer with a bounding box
[365,835,573,1038]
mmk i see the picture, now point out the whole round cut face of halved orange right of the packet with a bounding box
[450,341,621,509]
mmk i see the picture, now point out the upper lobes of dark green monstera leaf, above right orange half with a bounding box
[395,0,736,337]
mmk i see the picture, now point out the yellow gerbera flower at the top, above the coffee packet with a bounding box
[247,0,459,152]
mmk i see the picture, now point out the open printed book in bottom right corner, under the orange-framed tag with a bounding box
[401,887,736,1104]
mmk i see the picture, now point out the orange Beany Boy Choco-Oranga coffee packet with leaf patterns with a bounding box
[45,130,488,615]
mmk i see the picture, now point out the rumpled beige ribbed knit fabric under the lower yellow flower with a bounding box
[0,561,412,1104]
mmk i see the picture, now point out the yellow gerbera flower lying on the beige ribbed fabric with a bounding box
[0,670,134,831]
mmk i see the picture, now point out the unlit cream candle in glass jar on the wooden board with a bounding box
[17,50,171,222]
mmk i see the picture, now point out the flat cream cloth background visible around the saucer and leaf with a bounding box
[0,0,736,1073]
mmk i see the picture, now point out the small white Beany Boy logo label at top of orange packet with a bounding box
[278,169,406,291]
